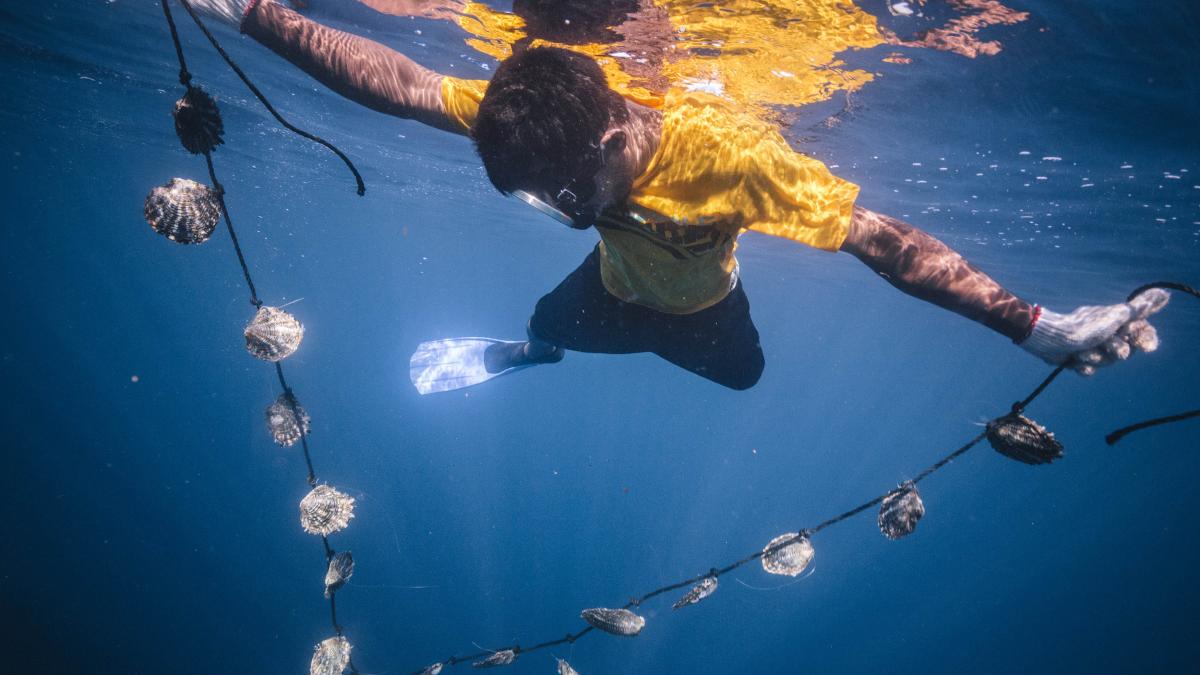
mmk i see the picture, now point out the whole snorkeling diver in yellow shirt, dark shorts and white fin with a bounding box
[190,0,1169,394]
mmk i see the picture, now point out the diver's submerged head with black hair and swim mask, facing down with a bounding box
[472,47,634,228]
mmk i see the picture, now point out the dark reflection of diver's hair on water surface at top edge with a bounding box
[512,0,638,44]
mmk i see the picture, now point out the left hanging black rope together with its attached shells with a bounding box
[152,0,355,675]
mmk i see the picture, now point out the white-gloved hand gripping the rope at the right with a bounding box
[1020,288,1171,375]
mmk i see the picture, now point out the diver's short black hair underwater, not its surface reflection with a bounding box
[472,47,629,195]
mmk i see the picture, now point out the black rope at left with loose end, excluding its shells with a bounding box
[162,0,350,662]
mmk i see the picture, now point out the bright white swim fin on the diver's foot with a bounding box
[408,338,535,395]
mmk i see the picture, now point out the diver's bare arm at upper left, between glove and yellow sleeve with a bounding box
[241,0,457,131]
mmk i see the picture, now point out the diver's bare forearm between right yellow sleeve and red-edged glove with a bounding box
[841,207,1034,340]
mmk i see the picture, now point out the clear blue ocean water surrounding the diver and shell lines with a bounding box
[0,0,1200,675]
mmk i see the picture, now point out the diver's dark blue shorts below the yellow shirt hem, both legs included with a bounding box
[529,251,764,389]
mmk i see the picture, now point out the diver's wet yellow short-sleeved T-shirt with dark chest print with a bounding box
[442,82,858,313]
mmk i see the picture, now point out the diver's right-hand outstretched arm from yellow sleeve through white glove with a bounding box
[841,207,1169,375]
